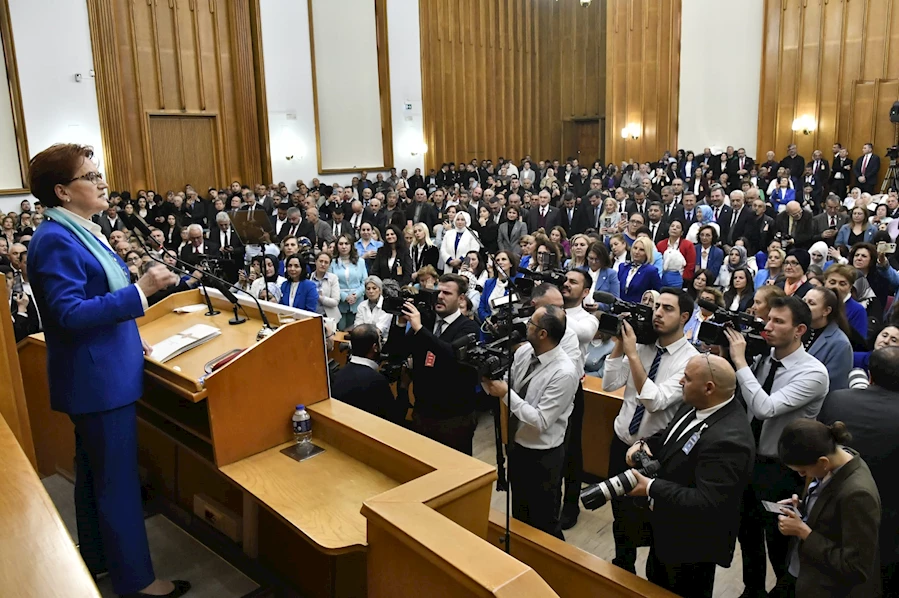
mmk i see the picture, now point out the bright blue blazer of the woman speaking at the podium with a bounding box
[28,220,144,415]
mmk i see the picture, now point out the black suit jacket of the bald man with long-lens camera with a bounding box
[647,399,755,567]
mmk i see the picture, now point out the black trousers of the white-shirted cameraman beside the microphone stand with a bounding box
[509,443,565,540]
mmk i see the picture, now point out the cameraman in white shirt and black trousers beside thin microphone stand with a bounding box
[481,305,578,539]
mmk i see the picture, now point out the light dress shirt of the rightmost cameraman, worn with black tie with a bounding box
[737,346,830,458]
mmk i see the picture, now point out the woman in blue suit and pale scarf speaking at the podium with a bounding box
[28,144,190,597]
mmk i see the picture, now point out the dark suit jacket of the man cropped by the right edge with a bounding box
[818,384,899,565]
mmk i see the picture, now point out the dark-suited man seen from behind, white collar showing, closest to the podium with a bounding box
[331,324,396,421]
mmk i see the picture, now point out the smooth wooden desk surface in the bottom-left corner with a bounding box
[0,418,100,598]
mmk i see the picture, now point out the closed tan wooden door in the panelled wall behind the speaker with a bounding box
[150,115,223,196]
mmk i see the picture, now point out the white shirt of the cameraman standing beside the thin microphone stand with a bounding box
[503,343,578,450]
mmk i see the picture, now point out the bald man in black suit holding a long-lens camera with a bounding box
[628,354,755,597]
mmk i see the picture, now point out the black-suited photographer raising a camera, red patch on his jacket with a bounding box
[385,274,479,455]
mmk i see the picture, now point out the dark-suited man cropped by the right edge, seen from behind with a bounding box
[818,347,899,596]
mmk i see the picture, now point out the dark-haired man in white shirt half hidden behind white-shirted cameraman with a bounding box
[561,268,599,530]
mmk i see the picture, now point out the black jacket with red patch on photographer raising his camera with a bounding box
[384,316,480,419]
